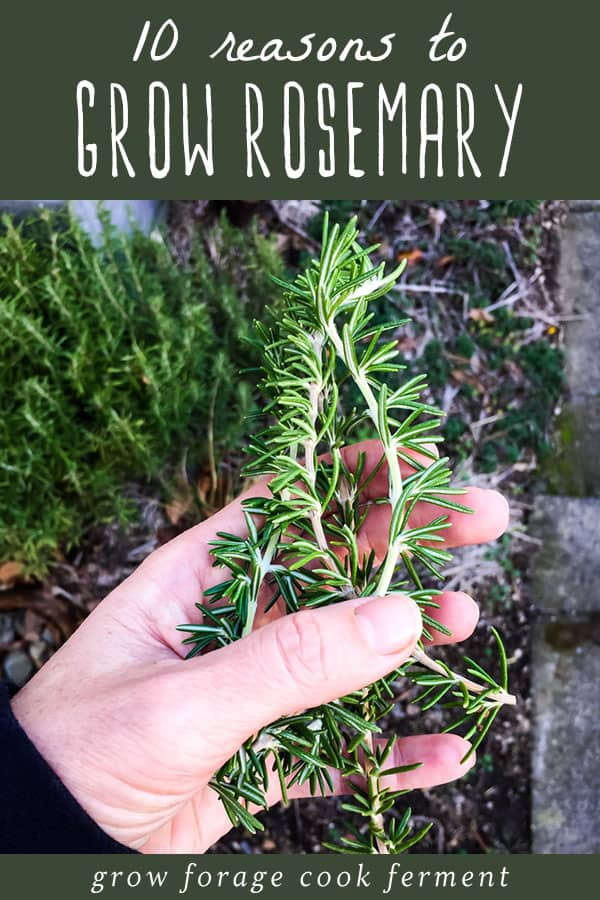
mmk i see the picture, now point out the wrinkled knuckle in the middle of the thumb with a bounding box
[275,610,331,685]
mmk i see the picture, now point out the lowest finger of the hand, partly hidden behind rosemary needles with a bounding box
[288,734,475,803]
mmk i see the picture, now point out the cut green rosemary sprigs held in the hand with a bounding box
[180,218,514,853]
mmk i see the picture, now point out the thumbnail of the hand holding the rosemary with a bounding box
[354,594,423,656]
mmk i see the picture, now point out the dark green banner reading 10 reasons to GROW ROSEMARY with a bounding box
[0,0,600,199]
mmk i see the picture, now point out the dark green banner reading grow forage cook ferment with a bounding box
[0,855,600,900]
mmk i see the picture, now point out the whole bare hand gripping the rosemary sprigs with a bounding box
[13,441,508,852]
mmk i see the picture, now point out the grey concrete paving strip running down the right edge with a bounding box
[530,207,600,853]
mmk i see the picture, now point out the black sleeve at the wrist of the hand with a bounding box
[0,682,134,853]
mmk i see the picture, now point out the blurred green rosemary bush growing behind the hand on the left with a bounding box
[0,213,281,575]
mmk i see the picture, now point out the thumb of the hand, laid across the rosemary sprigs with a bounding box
[186,594,422,759]
